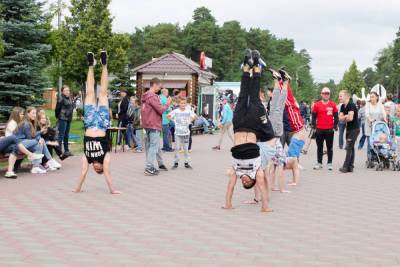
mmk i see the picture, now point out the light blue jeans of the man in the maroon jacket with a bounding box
[144,129,163,169]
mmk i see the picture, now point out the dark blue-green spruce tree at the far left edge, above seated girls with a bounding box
[0,0,50,112]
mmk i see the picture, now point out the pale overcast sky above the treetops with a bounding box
[50,0,400,82]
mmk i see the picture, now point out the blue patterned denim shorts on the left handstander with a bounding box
[84,105,110,131]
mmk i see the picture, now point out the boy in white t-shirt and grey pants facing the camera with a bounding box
[167,96,197,170]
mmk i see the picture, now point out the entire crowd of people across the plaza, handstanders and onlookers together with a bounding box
[0,49,400,206]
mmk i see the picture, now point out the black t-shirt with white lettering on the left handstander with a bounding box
[83,136,110,164]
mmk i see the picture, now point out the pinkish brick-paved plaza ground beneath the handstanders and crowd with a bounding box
[0,135,400,267]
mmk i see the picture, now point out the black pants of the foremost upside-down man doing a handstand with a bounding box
[232,72,272,136]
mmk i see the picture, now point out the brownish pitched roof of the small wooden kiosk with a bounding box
[133,52,217,84]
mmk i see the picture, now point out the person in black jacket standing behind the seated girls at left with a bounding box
[55,86,74,156]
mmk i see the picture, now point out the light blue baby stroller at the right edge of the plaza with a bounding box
[367,121,400,171]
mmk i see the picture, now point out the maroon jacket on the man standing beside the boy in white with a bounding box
[141,90,168,131]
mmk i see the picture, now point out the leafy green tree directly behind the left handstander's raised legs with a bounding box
[51,0,131,90]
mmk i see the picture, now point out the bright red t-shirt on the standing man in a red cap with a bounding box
[312,101,338,130]
